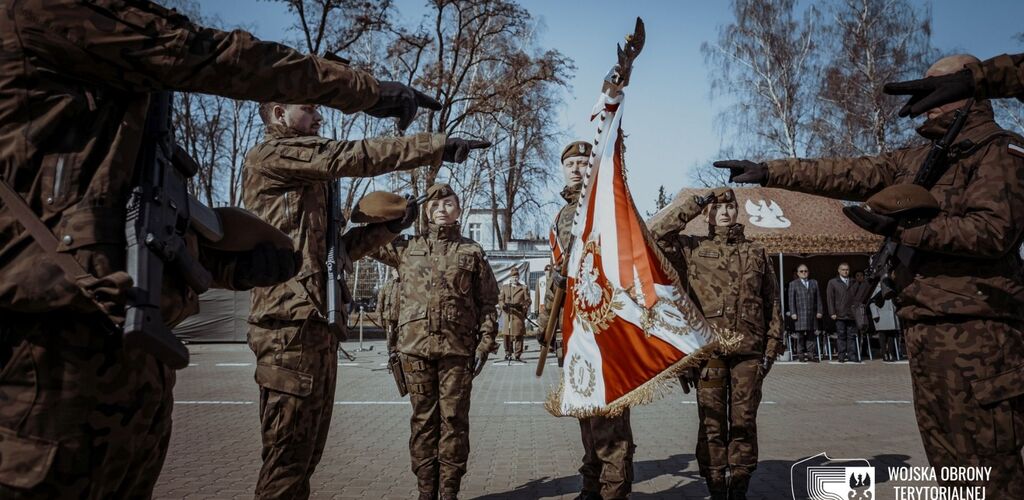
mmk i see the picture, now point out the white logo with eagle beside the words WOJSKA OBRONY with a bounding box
[790,453,874,500]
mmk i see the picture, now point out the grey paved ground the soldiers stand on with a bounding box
[156,341,927,500]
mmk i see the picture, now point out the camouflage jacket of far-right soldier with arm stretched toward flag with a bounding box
[767,101,1024,322]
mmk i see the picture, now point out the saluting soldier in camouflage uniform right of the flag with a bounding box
[650,188,785,500]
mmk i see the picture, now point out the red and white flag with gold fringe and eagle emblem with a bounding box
[546,93,729,417]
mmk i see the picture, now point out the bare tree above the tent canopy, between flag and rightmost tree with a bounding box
[700,0,819,157]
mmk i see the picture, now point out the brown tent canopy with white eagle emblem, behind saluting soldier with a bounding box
[651,188,882,254]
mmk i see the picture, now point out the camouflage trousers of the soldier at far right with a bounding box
[905,320,1024,498]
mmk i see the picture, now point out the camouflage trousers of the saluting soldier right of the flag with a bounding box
[696,356,762,491]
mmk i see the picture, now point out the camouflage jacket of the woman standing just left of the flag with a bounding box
[371,224,498,359]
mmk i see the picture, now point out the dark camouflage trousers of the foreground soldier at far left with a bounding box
[0,314,175,499]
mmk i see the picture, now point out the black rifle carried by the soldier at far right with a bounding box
[864,99,974,307]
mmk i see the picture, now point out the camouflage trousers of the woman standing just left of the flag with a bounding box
[401,355,473,498]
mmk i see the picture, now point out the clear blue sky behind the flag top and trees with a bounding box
[201,0,1024,215]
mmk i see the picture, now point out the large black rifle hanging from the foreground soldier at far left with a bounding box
[122,91,223,370]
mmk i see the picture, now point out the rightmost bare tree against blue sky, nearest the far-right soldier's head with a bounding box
[811,0,937,156]
